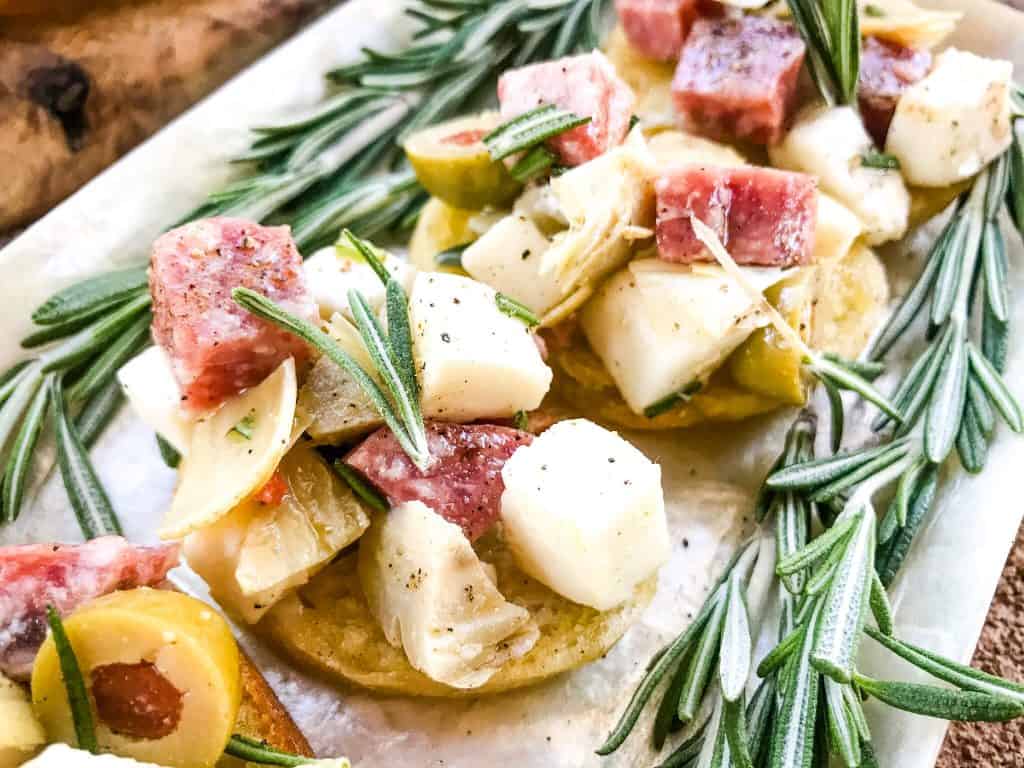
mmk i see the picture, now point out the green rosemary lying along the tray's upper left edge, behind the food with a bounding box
[0,0,608,536]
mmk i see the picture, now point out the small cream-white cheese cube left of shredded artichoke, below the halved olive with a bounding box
[462,214,562,316]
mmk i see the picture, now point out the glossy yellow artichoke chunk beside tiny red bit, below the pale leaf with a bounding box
[184,441,370,624]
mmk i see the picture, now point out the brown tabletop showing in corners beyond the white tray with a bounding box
[0,0,1024,768]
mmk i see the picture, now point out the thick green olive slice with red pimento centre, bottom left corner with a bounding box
[32,588,242,768]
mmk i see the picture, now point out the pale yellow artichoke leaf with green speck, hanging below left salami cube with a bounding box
[159,357,298,539]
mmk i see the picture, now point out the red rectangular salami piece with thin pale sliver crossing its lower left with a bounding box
[654,165,817,266]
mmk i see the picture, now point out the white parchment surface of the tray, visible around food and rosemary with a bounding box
[0,0,1024,768]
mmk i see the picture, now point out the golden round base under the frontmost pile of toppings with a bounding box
[256,537,657,696]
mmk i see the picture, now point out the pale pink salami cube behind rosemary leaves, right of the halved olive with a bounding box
[498,51,635,165]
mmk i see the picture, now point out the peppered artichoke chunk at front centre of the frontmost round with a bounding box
[358,502,540,688]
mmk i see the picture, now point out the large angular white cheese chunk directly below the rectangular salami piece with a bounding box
[581,259,785,414]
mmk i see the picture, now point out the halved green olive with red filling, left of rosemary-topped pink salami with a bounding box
[403,112,521,210]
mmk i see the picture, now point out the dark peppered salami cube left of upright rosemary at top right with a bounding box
[672,15,804,144]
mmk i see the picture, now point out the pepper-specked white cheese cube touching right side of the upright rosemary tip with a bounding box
[410,272,552,422]
